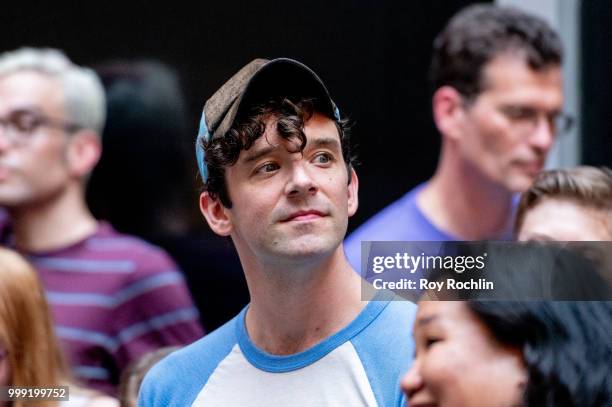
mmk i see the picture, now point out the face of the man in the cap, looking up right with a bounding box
[226,113,354,268]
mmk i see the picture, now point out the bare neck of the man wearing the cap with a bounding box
[245,246,367,355]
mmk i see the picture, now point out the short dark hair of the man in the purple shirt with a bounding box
[429,4,563,100]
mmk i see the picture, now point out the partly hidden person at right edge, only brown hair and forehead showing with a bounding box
[515,166,612,241]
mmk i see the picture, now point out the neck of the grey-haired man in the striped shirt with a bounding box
[9,188,98,253]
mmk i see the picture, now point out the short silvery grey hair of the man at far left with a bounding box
[0,47,106,135]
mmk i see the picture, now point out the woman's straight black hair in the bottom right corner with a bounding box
[430,241,612,407]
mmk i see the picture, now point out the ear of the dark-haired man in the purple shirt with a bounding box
[432,86,465,140]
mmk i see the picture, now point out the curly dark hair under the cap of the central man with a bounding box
[203,97,354,208]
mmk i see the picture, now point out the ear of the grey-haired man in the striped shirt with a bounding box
[66,130,102,178]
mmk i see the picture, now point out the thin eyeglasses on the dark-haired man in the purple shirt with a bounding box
[498,105,574,134]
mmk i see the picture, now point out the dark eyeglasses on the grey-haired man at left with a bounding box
[0,109,82,144]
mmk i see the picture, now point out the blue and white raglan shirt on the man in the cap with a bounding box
[138,292,416,407]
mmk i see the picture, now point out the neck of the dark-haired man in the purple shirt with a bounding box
[417,151,514,240]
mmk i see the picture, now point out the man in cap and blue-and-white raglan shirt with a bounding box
[139,59,415,406]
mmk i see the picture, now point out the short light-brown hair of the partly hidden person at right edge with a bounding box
[514,166,612,234]
